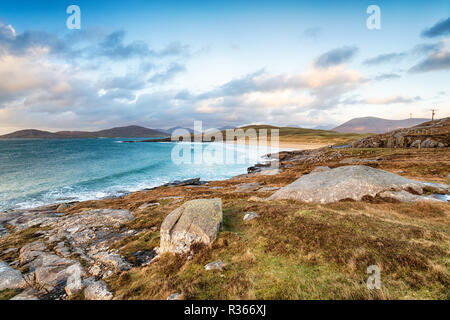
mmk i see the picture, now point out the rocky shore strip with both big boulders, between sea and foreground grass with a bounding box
[0,148,450,300]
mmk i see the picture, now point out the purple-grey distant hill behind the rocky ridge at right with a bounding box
[332,117,430,133]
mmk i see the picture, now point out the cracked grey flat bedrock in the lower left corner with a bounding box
[0,206,136,299]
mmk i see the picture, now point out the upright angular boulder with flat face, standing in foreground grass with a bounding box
[158,198,222,253]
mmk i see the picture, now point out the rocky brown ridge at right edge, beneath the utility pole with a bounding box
[352,118,450,148]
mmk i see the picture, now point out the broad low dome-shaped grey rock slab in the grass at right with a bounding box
[269,166,446,203]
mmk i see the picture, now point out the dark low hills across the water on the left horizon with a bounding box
[0,126,167,139]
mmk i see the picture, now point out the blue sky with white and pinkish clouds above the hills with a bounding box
[0,0,450,134]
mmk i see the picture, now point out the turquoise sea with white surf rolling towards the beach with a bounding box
[0,139,274,211]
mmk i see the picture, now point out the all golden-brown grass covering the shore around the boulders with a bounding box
[0,144,450,300]
